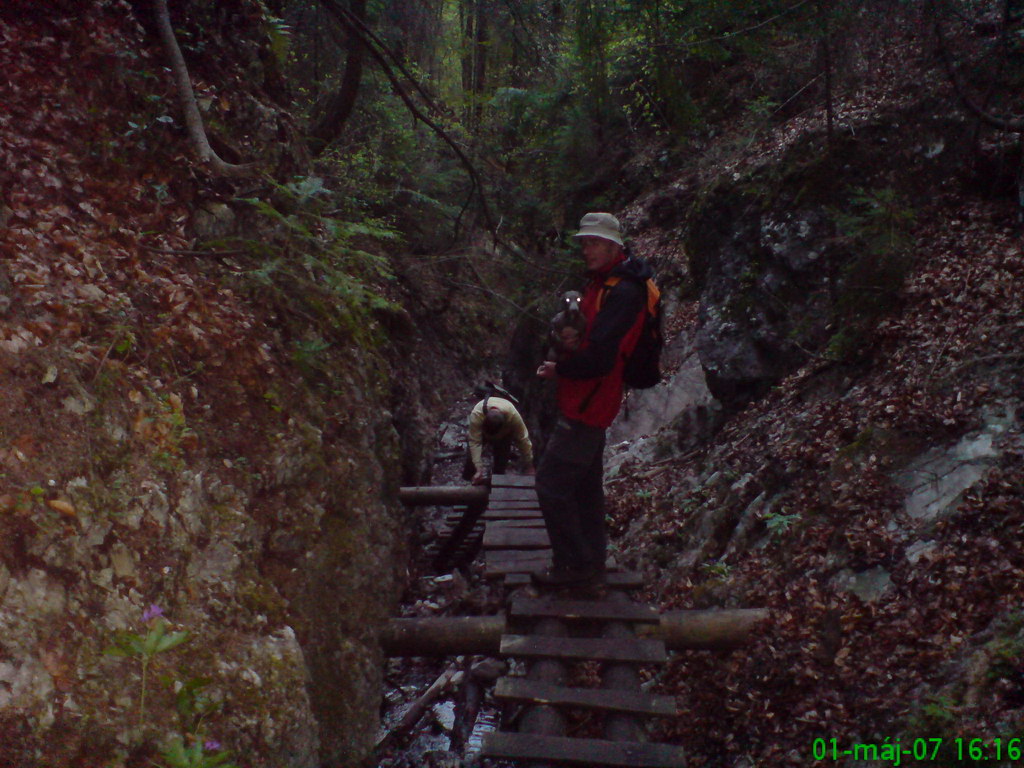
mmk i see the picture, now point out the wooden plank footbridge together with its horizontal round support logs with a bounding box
[395,475,767,768]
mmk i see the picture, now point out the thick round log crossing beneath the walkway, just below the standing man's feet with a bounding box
[381,608,768,656]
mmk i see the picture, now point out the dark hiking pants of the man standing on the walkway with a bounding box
[537,418,607,569]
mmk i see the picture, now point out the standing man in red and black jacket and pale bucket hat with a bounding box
[534,213,653,586]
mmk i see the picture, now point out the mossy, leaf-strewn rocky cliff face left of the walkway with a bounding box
[0,3,471,768]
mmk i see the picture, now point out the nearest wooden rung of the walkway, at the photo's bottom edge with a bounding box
[480,731,686,768]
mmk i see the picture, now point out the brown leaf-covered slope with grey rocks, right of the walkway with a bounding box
[612,16,1024,766]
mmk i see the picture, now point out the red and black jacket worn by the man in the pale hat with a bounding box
[555,257,654,427]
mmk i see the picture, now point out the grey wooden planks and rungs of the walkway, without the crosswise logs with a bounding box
[481,475,686,768]
